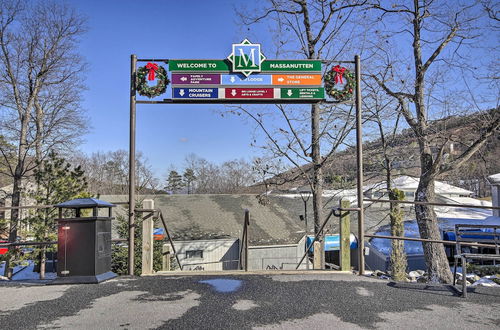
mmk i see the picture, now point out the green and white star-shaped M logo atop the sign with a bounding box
[227,39,266,77]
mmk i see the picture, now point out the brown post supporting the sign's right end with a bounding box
[354,55,365,276]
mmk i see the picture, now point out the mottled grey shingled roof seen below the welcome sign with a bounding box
[100,194,312,245]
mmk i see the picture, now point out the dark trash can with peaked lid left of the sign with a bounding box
[52,198,116,284]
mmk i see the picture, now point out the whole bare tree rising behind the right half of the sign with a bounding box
[236,0,365,265]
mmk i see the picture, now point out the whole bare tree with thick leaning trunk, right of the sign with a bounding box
[371,0,500,283]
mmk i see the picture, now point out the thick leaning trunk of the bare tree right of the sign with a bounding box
[415,146,453,283]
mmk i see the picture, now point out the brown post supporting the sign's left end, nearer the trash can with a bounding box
[128,55,137,275]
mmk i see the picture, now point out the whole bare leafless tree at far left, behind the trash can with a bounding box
[0,0,88,275]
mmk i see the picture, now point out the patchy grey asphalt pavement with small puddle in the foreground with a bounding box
[0,272,500,329]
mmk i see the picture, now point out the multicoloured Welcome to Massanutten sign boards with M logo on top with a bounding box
[168,39,325,103]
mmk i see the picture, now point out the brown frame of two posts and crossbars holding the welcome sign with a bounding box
[128,54,365,275]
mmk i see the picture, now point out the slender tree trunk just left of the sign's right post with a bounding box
[311,104,325,269]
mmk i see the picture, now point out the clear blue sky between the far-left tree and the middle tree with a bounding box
[68,0,267,174]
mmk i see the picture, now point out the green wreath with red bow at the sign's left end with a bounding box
[137,63,170,98]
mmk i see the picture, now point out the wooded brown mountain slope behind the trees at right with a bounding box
[245,109,500,197]
